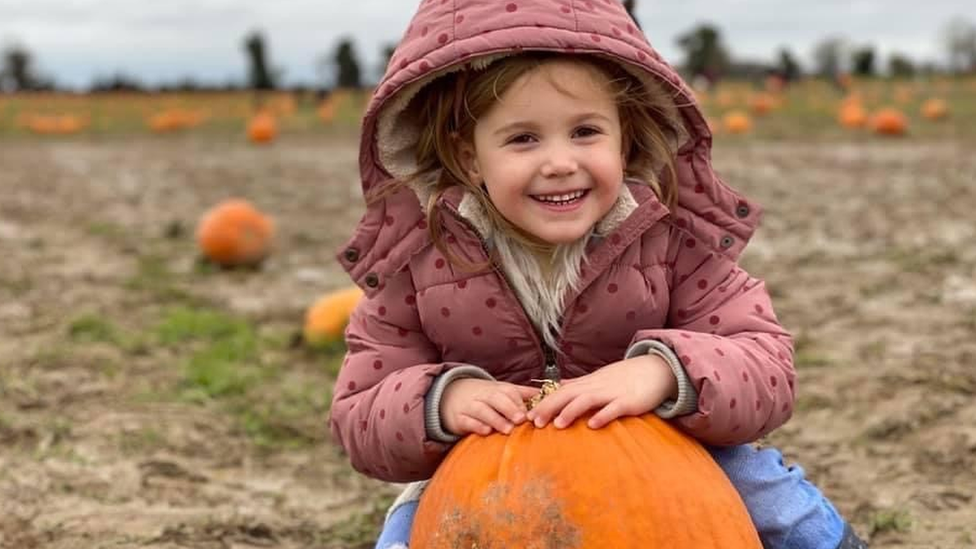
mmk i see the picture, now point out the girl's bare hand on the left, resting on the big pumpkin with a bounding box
[441,378,539,436]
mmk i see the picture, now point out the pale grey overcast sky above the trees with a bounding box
[0,0,976,87]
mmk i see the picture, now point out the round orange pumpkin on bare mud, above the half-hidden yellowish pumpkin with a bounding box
[196,199,274,267]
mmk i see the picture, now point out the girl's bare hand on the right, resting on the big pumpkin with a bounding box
[527,354,678,429]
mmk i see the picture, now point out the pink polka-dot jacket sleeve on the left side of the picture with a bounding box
[330,270,461,482]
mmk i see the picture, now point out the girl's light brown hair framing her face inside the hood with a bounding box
[390,52,682,270]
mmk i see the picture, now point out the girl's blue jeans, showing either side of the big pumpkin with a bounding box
[376,445,845,549]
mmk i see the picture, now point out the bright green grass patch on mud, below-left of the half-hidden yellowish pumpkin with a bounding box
[153,306,350,450]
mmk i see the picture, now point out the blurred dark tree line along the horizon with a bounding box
[0,9,976,91]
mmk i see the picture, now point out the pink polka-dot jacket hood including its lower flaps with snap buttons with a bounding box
[338,0,761,291]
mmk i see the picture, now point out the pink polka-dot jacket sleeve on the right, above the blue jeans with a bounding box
[631,228,795,445]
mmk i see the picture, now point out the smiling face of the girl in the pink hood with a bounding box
[461,60,624,244]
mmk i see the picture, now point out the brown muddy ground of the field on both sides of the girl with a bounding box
[0,137,976,549]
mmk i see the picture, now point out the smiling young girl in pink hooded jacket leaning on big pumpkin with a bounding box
[331,0,863,549]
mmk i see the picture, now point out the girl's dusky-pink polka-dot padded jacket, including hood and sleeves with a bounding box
[330,0,794,482]
